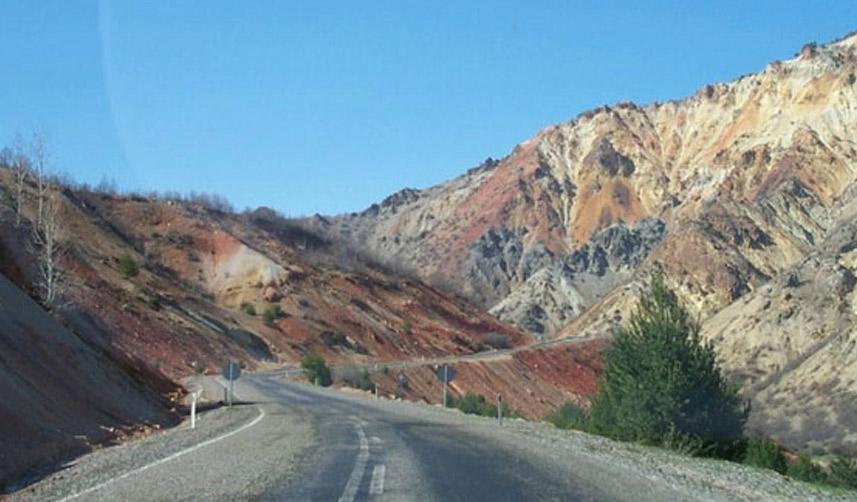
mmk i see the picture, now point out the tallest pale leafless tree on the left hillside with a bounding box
[31,186,66,310]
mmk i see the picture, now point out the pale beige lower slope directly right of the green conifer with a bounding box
[703,189,857,451]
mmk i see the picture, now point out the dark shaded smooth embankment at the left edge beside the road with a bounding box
[0,275,177,493]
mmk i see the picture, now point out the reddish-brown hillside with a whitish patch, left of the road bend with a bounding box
[0,177,528,380]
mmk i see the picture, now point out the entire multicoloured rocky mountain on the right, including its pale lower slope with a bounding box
[320,34,857,451]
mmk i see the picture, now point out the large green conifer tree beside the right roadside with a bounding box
[589,273,749,453]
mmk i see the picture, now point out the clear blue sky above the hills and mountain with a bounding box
[0,0,857,215]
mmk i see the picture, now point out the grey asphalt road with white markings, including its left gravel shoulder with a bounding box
[12,374,686,502]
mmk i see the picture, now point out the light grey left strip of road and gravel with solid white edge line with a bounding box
[8,388,317,501]
